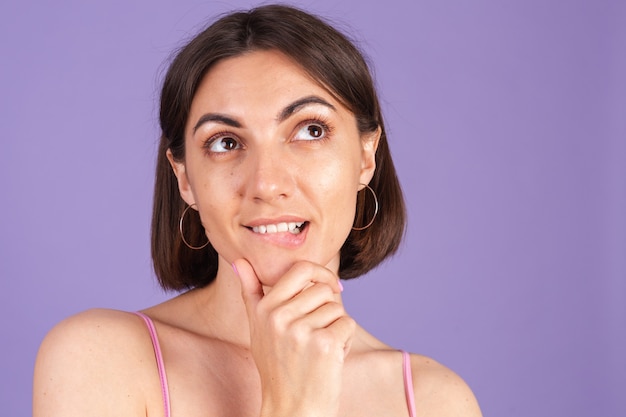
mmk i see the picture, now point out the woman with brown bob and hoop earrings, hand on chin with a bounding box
[34,6,480,417]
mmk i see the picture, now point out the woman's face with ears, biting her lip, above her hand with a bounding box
[168,51,378,286]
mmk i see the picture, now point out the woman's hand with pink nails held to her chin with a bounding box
[233,259,356,417]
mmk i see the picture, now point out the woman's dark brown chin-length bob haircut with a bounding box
[151,5,406,290]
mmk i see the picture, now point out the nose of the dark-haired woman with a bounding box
[246,147,296,202]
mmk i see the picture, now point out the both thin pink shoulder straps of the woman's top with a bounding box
[135,312,416,417]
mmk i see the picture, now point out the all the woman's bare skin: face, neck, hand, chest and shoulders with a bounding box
[33,51,480,417]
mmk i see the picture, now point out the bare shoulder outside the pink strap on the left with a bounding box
[33,310,158,417]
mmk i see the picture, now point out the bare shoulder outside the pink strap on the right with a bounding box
[411,354,482,417]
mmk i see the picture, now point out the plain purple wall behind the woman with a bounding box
[0,0,626,417]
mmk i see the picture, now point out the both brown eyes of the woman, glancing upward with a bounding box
[203,116,333,156]
